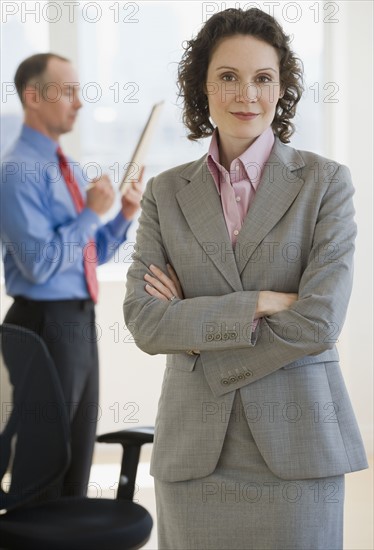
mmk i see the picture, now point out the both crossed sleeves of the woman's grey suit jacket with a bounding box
[124,165,356,384]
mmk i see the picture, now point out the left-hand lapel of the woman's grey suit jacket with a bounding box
[176,155,243,291]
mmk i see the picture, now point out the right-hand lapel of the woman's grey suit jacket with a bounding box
[235,139,305,273]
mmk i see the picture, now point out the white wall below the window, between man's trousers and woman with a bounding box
[93,281,165,438]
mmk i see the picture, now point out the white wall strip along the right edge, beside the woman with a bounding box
[325,1,373,453]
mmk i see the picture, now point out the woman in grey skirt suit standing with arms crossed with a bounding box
[124,9,367,550]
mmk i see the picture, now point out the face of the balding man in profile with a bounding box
[25,58,82,141]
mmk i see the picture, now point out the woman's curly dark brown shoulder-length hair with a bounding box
[178,8,304,143]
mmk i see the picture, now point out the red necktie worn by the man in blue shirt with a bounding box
[57,147,99,303]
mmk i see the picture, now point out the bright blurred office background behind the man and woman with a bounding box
[1,0,373,550]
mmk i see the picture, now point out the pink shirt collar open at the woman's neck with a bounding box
[207,126,275,193]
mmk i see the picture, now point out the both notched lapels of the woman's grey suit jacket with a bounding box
[176,139,305,291]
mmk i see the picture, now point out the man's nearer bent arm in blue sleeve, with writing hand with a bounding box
[1,169,114,284]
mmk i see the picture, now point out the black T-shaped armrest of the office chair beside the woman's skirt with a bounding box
[96,427,154,500]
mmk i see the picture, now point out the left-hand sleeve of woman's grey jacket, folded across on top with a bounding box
[124,179,259,355]
